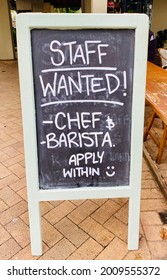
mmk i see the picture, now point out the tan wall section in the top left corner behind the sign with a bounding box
[0,0,15,60]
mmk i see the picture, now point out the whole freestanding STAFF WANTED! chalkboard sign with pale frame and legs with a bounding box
[17,13,148,255]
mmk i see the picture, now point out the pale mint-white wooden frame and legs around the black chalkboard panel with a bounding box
[17,13,148,255]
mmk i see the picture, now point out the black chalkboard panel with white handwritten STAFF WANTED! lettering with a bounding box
[31,29,135,189]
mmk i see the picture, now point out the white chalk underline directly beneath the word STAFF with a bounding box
[41,67,117,73]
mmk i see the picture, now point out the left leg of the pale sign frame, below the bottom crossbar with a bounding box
[29,201,42,256]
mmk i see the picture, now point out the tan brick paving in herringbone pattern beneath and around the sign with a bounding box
[0,61,167,260]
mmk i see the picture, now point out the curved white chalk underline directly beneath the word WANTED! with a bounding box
[41,99,124,107]
